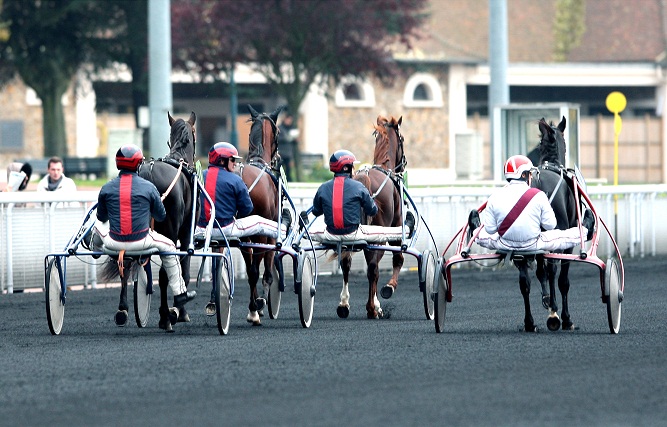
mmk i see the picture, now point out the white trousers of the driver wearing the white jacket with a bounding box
[476,227,588,252]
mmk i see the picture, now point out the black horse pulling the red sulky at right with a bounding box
[515,117,577,332]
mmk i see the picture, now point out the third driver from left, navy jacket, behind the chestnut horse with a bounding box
[310,150,415,243]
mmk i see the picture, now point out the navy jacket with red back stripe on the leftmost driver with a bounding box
[97,170,167,242]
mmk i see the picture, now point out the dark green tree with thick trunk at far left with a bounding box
[0,0,122,157]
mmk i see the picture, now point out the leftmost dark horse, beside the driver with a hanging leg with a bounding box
[102,112,198,331]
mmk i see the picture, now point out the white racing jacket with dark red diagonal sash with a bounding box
[481,180,556,242]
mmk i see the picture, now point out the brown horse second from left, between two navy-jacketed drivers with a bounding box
[240,105,285,325]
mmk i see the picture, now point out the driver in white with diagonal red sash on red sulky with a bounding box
[468,155,595,251]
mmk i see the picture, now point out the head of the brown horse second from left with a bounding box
[246,105,285,165]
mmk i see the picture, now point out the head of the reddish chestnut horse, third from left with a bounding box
[373,116,407,173]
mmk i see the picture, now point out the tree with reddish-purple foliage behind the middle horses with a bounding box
[172,0,428,179]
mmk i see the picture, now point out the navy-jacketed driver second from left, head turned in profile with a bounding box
[195,142,291,238]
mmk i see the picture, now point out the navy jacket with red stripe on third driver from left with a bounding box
[313,173,378,234]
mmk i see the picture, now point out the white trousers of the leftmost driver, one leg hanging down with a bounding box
[95,221,187,296]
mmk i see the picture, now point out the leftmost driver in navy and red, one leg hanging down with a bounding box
[93,144,197,331]
